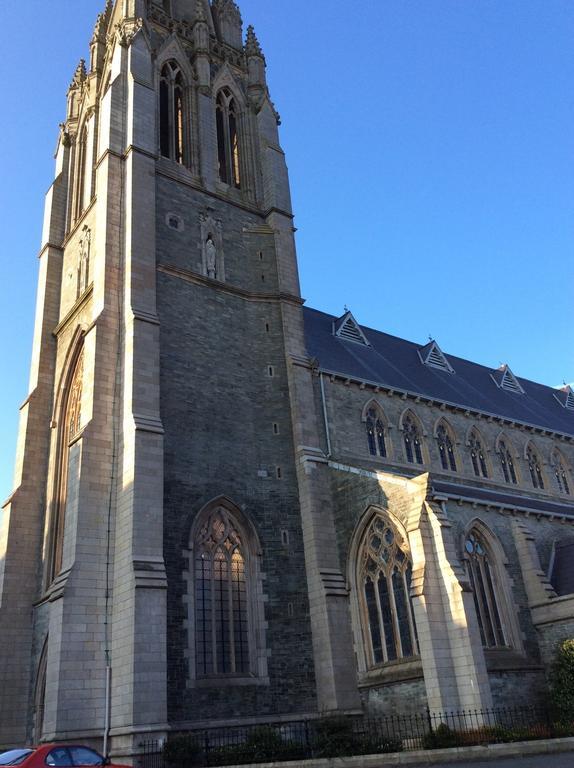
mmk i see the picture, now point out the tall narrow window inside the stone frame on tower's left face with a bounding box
[48,349,84,582]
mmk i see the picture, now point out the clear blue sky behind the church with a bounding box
[0,0,574,498]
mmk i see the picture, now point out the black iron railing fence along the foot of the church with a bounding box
[140,707,574,768]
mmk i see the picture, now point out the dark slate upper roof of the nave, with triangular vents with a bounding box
[303,307,574,436]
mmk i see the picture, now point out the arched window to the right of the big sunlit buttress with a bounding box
[461,517,522,651]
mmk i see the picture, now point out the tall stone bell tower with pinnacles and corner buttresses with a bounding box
[0,0,359,754]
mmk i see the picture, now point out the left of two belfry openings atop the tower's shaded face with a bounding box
[159,61,185,164]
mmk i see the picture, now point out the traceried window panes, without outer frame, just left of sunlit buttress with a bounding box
[358,515,418,666]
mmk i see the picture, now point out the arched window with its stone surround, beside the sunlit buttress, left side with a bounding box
[347,506,419,674]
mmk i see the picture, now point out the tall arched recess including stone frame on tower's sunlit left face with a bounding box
[45,328,84,586]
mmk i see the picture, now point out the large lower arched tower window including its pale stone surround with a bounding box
[184,496,268,685]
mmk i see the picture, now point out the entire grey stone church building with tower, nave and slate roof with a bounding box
[0,0,574,755]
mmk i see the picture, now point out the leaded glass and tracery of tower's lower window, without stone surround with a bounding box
[194,507,250,677]
